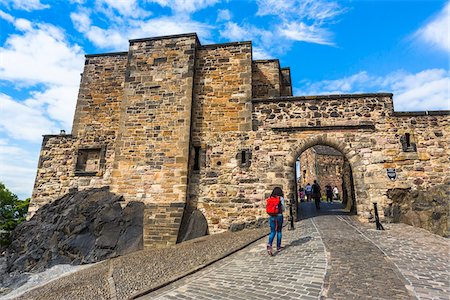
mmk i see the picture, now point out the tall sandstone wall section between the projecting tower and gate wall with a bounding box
[189,42,255,233]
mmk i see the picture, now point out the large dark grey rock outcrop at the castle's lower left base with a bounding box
[7,188,144,273]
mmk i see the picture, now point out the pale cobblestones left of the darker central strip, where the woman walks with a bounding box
[142,219,326,299]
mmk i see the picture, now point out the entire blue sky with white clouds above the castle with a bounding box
[0,0,450,198]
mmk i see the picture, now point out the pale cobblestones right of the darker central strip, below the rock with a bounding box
[344,218,450,300]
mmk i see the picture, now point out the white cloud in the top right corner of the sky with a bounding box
[414,1,450,52]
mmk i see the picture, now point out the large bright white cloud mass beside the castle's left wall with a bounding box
[0,14,84,138]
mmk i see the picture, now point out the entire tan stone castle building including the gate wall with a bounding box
[30,34,450,246]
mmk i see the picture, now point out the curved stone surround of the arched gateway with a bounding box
[285,134,370,218]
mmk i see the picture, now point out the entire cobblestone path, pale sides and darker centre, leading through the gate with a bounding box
[142,203,450,299]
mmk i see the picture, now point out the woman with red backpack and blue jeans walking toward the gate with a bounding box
[266,187,284,256]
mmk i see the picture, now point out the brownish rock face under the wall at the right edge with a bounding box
[384,185,450,236]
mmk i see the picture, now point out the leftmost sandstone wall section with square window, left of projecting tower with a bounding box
[29,52,127,216]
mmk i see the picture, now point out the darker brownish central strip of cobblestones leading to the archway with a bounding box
[308,203,414,299]
